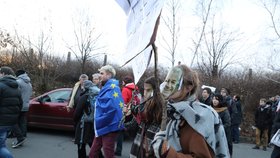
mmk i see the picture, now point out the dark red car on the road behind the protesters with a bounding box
[27,88,74,131]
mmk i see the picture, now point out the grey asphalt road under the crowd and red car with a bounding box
[7,129,272,158]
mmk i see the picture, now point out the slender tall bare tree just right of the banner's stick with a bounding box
[162,0,181,67]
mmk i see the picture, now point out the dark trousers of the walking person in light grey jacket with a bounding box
[12,111,27,141]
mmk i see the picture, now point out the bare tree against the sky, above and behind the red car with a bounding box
[67,12,104,73]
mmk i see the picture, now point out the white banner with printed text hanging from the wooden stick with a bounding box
[116,0,165,83]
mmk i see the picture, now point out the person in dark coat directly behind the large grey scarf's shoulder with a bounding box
[212,94,233,157]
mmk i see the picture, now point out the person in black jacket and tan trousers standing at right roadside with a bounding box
[253,98,272,151]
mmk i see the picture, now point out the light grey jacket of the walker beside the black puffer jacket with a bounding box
[17,73,32,111]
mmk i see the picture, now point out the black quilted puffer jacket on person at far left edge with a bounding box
[0,75,22,126]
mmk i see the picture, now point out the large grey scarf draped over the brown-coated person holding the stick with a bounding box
[166,96,230,158]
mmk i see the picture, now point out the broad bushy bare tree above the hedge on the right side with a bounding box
[196,20,240,80]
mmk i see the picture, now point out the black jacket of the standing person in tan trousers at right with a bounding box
[255,106,272,130]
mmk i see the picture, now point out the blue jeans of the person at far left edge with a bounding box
[0,126,13,158]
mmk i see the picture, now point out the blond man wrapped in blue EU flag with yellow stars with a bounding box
[89,65,124,158]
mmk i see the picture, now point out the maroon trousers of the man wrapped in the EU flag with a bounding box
[89,132,118,158]
